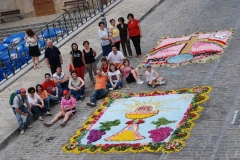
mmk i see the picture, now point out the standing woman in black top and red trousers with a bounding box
[69,43,86,80]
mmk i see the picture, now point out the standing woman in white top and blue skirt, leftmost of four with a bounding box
[98,22,112,58]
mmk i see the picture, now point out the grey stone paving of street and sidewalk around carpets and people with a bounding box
[0,0,240,160]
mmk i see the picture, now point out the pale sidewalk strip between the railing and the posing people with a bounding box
[0,0,160,144]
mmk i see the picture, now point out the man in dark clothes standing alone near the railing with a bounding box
[45,39,63,74]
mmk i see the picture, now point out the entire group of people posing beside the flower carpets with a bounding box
[12,14,165,134]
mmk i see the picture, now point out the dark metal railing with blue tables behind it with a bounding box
[0,0,117,84]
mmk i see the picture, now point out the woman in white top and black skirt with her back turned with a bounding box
[24,29,41,69]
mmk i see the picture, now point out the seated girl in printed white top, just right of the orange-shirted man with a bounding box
[107,63,122,90]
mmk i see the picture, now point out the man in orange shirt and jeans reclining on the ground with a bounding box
[87,69,108,107]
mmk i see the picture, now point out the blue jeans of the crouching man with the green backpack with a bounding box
[13,105,32,130]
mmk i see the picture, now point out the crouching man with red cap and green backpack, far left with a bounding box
[12,88,32,134]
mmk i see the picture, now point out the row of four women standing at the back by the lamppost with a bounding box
[98,13,142,58]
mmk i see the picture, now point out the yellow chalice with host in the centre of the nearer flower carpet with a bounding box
[105,105,159,141]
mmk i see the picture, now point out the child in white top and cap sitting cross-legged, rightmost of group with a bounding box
[145,64,165,88]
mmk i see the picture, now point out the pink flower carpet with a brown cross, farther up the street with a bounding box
[139,29,234,68]
